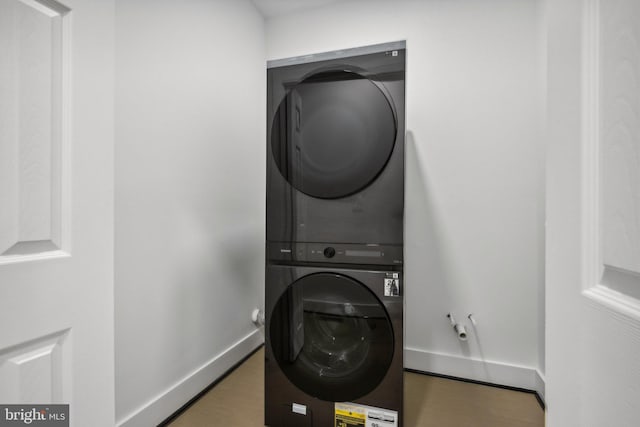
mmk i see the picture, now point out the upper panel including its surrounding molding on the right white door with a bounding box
[581,0,640,321]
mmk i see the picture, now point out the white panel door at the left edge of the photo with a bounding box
[0,0,114,427]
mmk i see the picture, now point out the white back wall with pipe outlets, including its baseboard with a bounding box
[266,0,545,391]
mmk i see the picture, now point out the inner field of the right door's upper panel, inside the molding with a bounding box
[599,0,640,292]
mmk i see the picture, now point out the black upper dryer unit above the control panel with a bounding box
[266,42,405,252]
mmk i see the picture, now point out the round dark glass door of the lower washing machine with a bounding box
[269,273,394,402]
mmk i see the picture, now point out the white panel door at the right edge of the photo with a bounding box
[546,0,640,427]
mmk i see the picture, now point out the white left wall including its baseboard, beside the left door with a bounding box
[115,0,266,427]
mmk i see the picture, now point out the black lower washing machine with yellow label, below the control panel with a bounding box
[265,264,403,427]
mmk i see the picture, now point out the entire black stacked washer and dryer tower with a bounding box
[265,42,405,427]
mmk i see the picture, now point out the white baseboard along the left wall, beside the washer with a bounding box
[116,330,264,427]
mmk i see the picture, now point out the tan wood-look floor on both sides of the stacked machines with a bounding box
[170,349,544,427]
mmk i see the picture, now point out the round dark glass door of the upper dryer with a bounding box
[271,71,396,199]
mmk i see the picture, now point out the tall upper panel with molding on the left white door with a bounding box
[0,0,69,262]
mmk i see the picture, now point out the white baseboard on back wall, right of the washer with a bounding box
[404,348,544,399]
